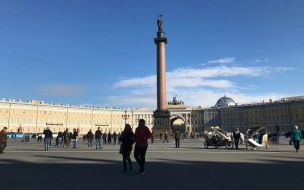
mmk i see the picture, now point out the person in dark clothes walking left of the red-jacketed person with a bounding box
[119,124,135,173]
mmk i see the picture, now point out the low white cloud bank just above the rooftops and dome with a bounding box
[104,88,290,109]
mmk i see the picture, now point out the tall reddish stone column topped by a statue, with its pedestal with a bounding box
[152,15,171,134]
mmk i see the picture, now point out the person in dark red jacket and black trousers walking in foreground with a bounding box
[134,119,152,174]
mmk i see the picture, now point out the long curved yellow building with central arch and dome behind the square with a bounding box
[0,96,304,134]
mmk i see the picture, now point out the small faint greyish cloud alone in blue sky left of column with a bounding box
[39,84,84,96]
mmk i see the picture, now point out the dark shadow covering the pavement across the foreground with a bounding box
[0,155,304,190]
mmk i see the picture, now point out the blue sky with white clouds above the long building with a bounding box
[0,0,304,108]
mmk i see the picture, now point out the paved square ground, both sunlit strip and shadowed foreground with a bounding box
[0,139,304,190]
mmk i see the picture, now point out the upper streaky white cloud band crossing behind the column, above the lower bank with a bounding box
[113,66,291,89]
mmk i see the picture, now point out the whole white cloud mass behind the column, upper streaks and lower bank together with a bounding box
[103,61,292,108]
